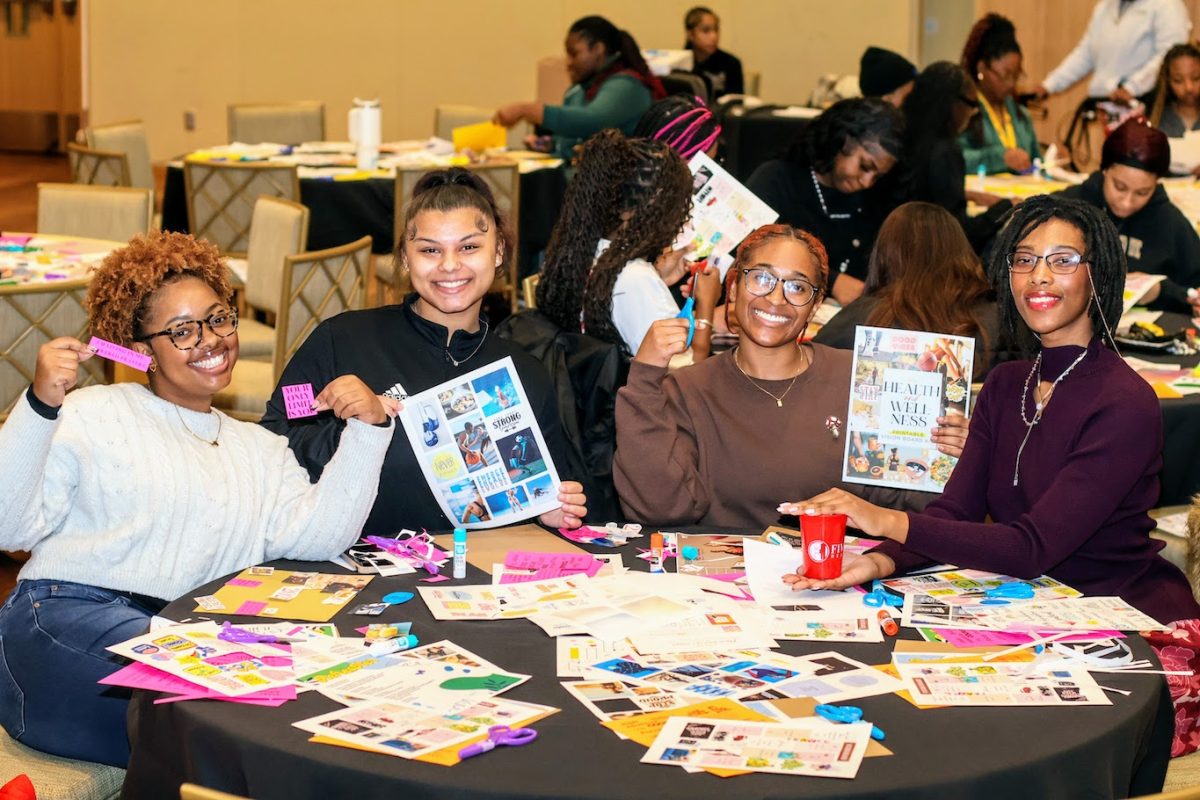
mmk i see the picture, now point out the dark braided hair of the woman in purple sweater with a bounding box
[988,194,1128,354]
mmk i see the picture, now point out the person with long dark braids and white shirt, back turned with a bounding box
[538,131,720,360]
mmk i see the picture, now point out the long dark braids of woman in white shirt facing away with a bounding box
[538,130,691,344]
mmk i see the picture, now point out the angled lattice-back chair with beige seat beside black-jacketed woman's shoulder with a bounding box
[212,236,371,421]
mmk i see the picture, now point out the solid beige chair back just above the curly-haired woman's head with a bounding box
[37,184,154,242]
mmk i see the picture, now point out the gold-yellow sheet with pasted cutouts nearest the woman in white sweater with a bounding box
[192,567,374,622]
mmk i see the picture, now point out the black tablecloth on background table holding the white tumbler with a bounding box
[162,167,566,276]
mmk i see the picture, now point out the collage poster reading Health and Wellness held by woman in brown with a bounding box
[841,325,974,493]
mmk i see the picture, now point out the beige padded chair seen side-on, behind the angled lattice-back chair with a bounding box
[229,196,310,361]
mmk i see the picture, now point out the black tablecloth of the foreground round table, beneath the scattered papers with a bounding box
[122,529,1174,800]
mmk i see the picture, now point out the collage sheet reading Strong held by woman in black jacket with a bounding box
[401,359,560,528]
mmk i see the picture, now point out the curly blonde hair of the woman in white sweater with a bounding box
[84,231,233,347]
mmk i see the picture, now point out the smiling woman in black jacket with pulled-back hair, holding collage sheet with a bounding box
[263,167,587,535]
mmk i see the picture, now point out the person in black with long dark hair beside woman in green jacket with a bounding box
[899,61,1013,252]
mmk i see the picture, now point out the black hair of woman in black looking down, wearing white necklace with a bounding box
[787,97,904,174]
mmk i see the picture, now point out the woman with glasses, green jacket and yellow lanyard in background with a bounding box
[959,14,1042,175]
